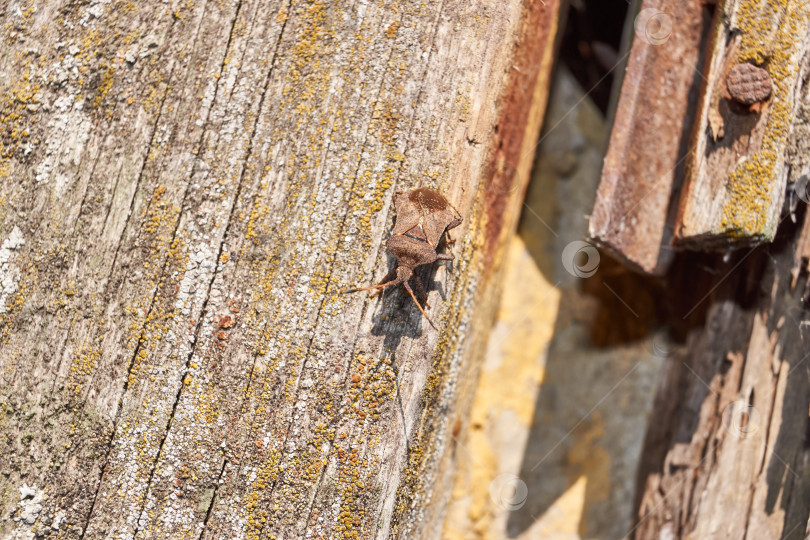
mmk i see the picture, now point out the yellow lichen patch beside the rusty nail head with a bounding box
[720,0,808,238]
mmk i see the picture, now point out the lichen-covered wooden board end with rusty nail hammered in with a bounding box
[675,0,810,250]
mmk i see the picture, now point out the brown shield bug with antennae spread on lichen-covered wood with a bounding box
[341,188,462,328]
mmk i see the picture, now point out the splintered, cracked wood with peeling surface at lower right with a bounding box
[634,208,810,540]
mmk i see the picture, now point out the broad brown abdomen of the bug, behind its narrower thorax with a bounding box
[393,188,461,247]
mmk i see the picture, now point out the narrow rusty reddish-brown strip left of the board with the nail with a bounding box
[589,0,711,274]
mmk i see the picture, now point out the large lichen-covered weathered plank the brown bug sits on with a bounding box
[0,0,557,539]
